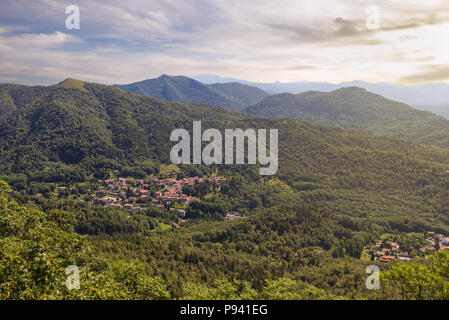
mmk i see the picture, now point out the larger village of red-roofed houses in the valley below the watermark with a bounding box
[91,177,225,213]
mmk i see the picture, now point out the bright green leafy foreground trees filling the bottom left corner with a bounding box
[0,181,169,299]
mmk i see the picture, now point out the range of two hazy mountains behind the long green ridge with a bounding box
[116,75,449,147]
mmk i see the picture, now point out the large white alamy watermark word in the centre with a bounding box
[170,121,278,175]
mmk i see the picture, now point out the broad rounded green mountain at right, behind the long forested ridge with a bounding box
[245,87,449,147]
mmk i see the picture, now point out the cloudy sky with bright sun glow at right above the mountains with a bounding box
[0,0,449,85]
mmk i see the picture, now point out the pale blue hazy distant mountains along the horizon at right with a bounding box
[193,74,449,117]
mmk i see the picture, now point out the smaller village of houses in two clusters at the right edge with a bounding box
[371,231,449,263]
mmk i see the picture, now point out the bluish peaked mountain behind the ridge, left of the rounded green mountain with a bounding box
[115,75,267,110]
